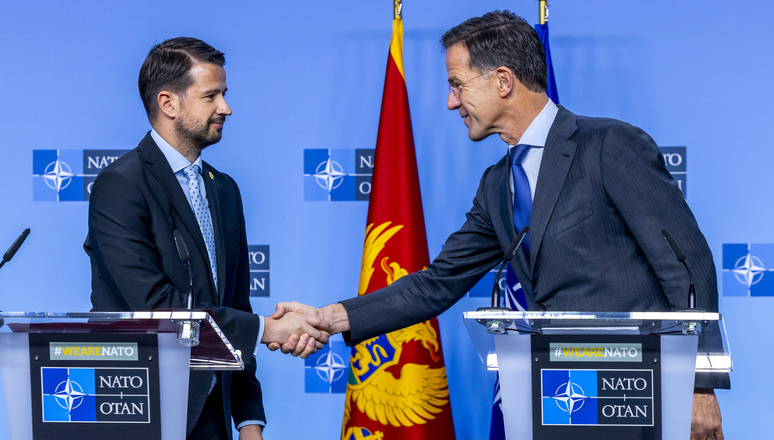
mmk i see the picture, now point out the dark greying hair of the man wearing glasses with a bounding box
[441,9,548,92]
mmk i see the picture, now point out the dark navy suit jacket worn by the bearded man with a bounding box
[84,133,265,435]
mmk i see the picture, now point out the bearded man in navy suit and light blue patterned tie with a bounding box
[84,38,327,440]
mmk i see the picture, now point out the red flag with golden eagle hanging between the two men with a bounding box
[341,18,454,440]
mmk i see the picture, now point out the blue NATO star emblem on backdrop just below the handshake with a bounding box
[304,341,351,394]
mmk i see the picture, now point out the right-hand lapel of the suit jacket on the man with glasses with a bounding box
[529,107,578,273]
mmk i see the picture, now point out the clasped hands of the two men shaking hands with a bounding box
[261,302,349,359]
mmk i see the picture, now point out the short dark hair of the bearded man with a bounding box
[137,37,226,122]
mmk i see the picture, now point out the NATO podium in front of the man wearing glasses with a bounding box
[463,310,732,440]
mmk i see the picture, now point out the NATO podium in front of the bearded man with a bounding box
[0,311,244,440]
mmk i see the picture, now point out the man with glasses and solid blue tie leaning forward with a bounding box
[278,11,729,439]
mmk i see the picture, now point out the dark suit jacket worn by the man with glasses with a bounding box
[342,107,722,387]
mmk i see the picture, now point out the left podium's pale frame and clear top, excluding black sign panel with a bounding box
[0,310,244,440]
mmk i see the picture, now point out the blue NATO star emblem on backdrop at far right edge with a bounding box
[723,243,774,296]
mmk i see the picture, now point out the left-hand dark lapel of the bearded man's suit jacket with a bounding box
[140,133,217,296]
